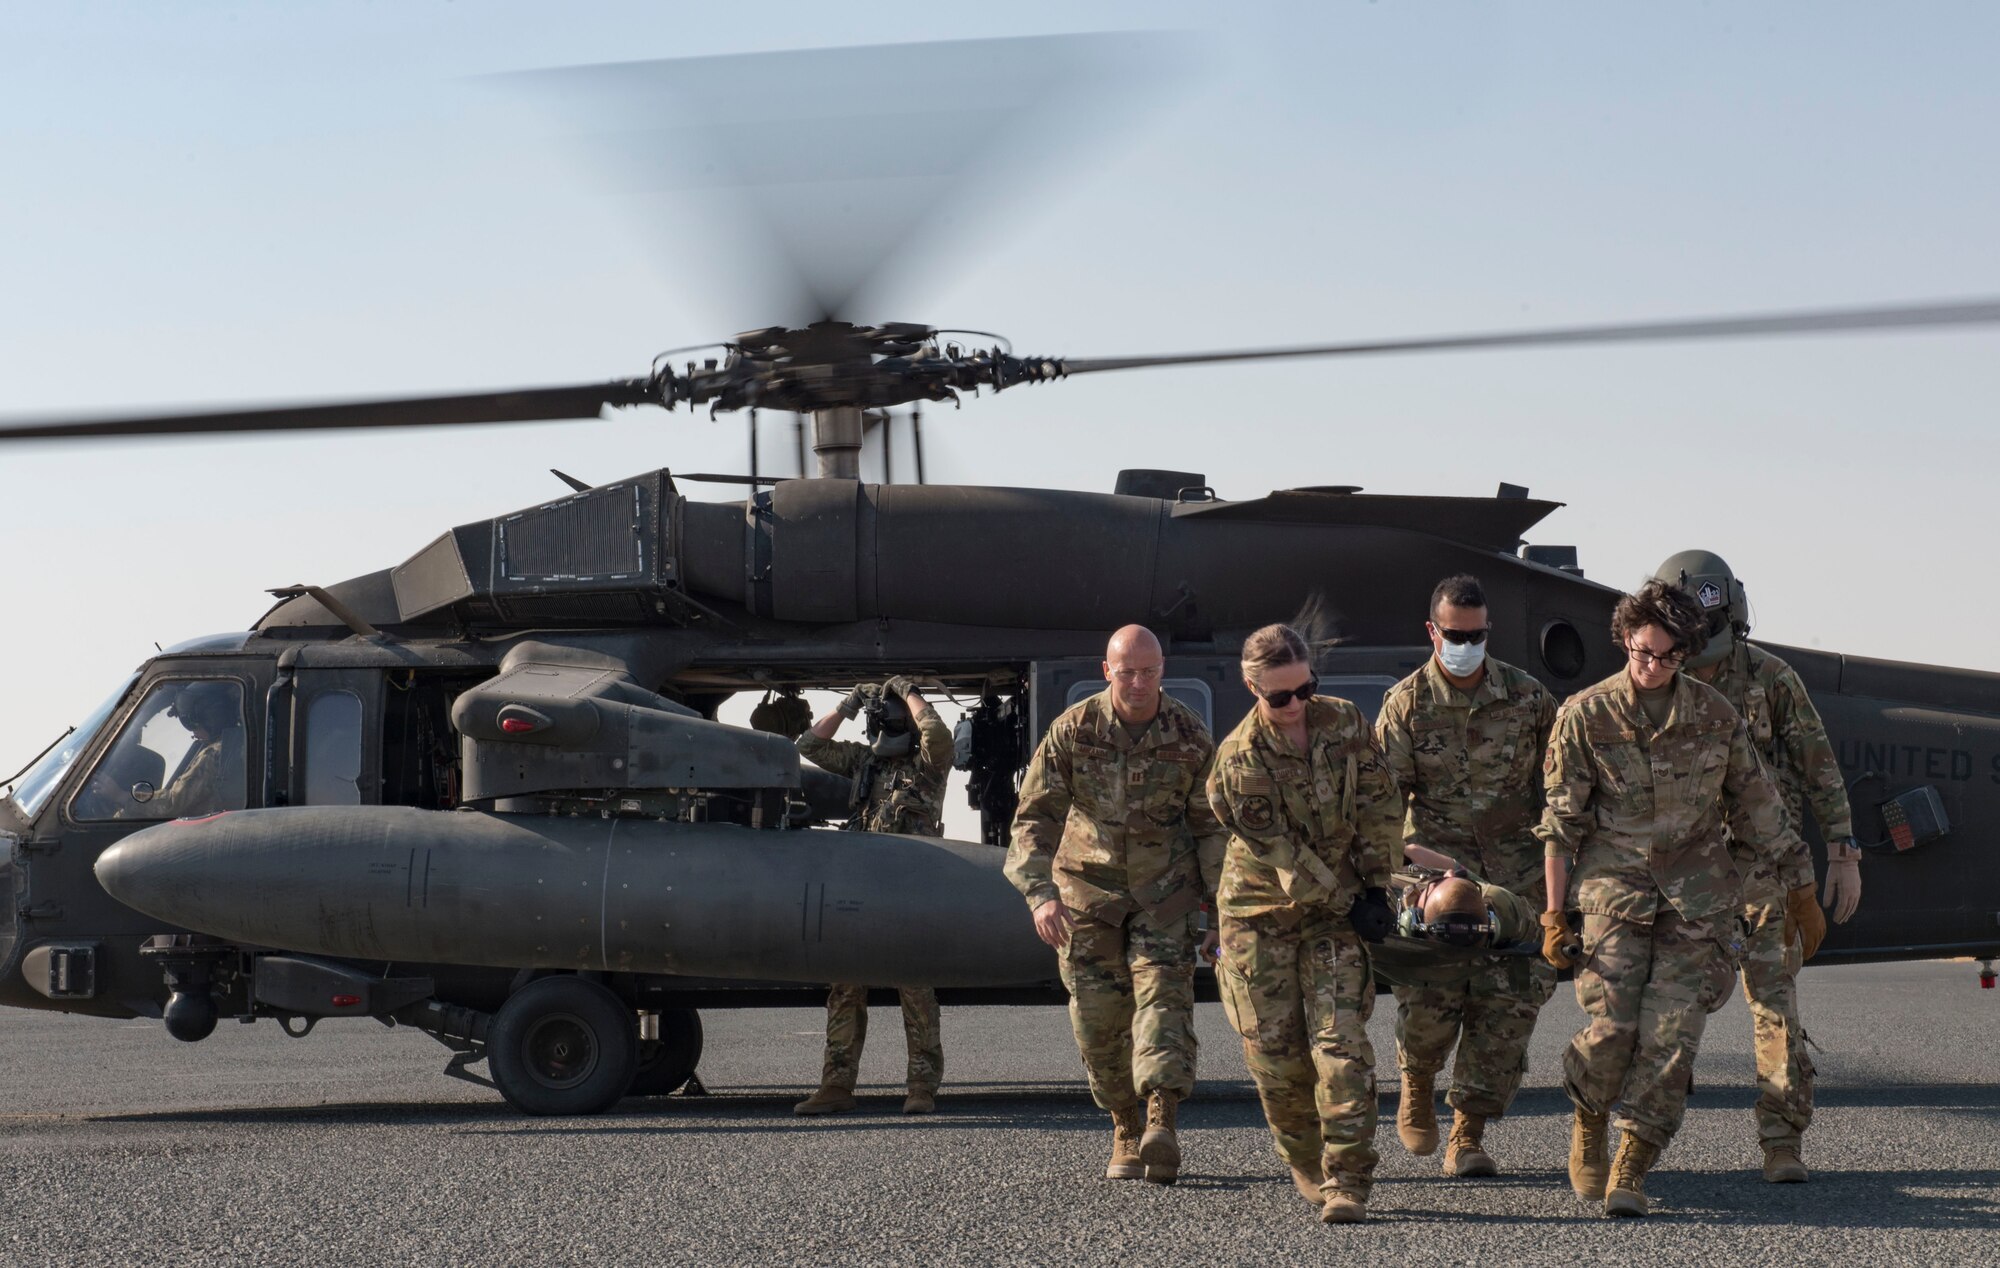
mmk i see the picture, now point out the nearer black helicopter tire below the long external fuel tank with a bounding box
[486,974,638,1114]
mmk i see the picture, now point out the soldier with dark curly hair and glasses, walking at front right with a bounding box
[1536,580,1826,1216]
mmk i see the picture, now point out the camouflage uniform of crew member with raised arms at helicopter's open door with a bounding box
[798,704,952,1092]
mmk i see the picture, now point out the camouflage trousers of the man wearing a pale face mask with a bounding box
[1394,956,1556,1118]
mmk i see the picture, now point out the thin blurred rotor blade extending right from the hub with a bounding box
[1062,300,2000,376]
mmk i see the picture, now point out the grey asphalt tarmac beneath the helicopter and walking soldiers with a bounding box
[0,962,2000,1268]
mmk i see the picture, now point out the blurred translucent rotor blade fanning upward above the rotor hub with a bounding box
[490,32,1190,326]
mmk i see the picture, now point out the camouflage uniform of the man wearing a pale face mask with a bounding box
[1376,658,1556,1118]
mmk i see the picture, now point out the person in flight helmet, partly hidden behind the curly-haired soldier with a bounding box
[1654,550,1862,1184]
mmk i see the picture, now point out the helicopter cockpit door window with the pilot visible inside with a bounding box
[70,680,248,820]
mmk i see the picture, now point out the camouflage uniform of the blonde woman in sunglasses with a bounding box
[1208,696,1402,1202]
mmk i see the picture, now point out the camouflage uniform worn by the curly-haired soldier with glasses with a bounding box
[1536,670,1812,1148]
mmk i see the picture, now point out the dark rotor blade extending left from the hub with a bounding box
[0,380,650,442]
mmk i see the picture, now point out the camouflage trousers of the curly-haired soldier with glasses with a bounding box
[1562,906,1736,1148]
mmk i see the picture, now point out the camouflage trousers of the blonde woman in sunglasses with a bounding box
[1216,912,1376,1200]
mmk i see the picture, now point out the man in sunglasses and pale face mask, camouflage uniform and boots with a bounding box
[1376,576,1556,1176]
